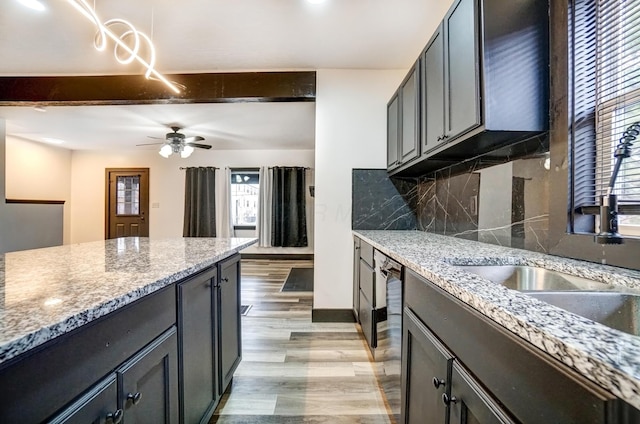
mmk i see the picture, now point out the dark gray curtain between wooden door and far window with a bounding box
[182,166,216,237]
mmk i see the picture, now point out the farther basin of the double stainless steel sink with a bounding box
[459,265,611,291]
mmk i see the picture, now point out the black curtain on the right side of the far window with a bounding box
[271,166,307,247]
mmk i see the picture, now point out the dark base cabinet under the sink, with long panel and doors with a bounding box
[402,270,640,424]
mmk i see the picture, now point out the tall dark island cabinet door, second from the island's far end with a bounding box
[178,268,217,424]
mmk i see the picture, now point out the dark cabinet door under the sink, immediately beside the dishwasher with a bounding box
[401,308,453,424]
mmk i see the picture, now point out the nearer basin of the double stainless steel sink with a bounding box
[527,291,640,336]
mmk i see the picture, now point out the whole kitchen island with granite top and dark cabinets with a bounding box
[0,238,256,423]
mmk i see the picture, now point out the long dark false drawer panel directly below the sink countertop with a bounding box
[405,270,623,424]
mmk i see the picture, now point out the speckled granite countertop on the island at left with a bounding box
[0,237,256,364]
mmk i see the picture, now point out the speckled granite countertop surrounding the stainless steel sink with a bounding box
[354,230,640,409]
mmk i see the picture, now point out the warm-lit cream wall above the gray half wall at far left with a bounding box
[5,136,71,243]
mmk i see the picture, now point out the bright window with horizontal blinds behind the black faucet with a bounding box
[570,0,640,235]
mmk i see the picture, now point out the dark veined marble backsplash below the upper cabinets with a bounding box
[352,154,549,252]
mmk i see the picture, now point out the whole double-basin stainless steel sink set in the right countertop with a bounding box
[459,265,640,336]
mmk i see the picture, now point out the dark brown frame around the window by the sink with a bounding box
[549,0,640,269]
